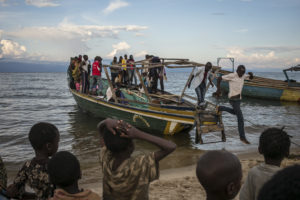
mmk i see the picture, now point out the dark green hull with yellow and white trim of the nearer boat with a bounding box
[70,90,194,135]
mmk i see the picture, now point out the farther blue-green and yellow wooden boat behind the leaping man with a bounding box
[214,65,300,102]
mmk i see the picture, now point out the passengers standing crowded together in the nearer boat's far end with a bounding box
[68,54,166,99]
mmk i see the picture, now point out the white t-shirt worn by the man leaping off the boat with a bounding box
[222,72,249,98]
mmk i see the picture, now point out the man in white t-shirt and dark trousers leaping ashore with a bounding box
[215,65,253,144]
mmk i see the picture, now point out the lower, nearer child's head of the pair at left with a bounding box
[48,151,81,188]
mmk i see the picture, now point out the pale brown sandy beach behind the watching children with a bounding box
[81,149,300,200]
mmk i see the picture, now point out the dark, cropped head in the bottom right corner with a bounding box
[257,165,300,200]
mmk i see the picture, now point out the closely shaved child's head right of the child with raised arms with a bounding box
[196,150,242,199]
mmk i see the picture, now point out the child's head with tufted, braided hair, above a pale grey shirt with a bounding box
[258,128,291,160]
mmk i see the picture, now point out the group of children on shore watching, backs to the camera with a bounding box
[0,119,300,200]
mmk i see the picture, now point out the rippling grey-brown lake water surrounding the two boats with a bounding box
[0,71,300,185]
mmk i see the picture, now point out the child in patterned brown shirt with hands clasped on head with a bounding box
[98,119,176,200]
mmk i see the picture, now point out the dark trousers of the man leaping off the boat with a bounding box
[219,99,246,139]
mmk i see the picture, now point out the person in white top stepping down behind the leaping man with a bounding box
[188,62,214,107]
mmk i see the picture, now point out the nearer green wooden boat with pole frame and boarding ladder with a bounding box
[70,59,225,143]
